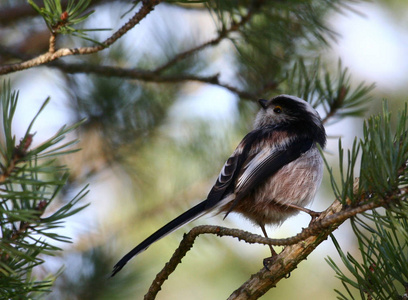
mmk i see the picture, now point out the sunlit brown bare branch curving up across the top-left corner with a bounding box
[0,0,162,75]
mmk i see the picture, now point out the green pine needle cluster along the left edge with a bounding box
[0,84,87,299]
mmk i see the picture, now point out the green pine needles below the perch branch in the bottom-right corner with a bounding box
[327,211,408,300]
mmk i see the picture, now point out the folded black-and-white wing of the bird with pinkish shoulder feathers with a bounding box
[207,129,313,215]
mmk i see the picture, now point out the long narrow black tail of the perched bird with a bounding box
[111,200,208,277]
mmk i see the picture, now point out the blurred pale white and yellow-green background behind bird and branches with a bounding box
[0,0,408,299]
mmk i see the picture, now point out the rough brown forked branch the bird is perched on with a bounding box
[144,181,401,300]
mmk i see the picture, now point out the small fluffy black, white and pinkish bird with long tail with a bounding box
[111,94,326,277]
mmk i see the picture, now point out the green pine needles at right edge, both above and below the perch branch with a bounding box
[328,103,408,300]
